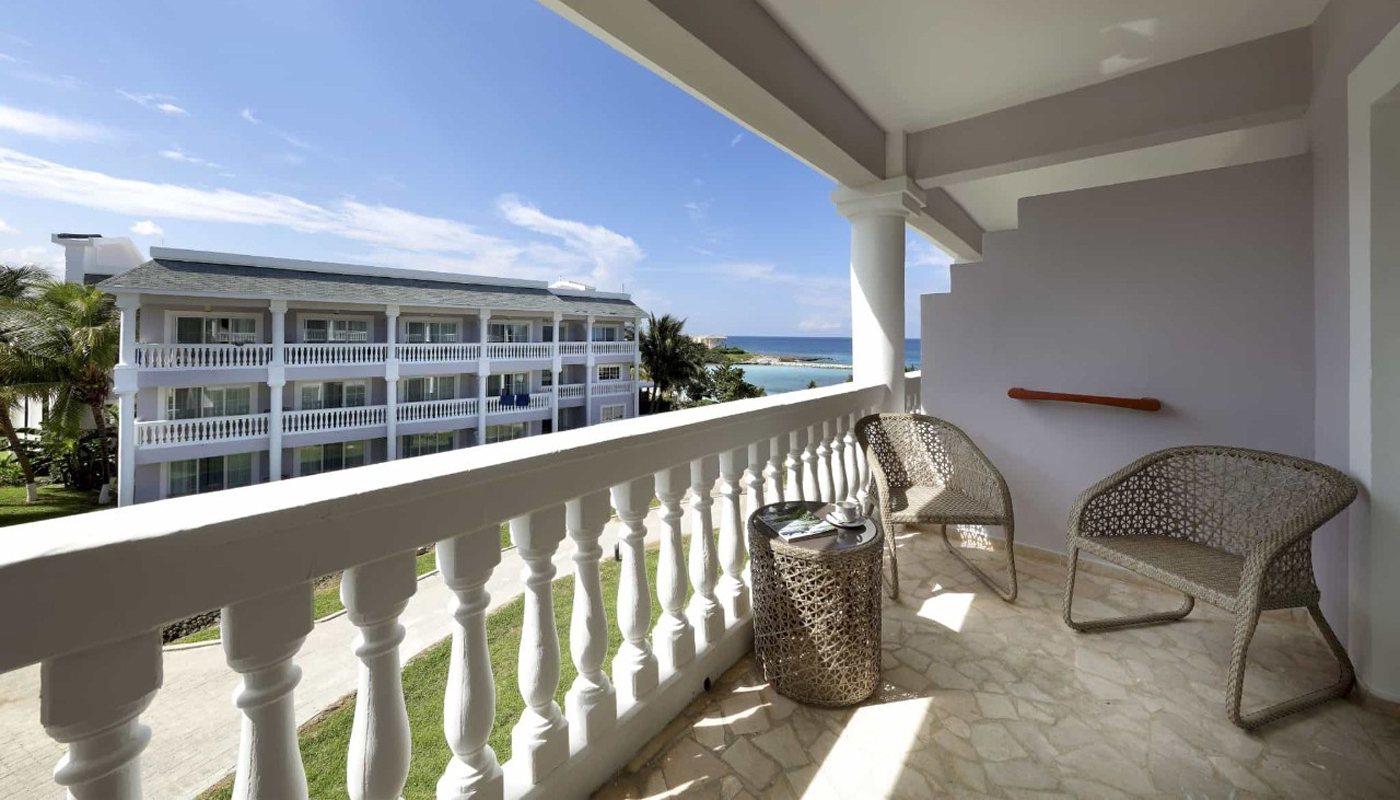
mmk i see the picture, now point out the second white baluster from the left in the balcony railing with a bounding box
[220,583,314,800]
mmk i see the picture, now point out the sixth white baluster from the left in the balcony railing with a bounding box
[564,492,617,752]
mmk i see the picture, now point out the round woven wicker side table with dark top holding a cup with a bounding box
[749,503,885,706]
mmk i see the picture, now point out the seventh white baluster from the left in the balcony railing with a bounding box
[612,475,657,701]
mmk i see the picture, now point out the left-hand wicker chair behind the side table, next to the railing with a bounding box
[855,413,1016,602]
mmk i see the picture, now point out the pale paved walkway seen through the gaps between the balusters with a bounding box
[0,509,677,797]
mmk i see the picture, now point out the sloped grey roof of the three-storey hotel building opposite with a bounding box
[98,258,644,317]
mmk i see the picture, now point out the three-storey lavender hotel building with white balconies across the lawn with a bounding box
[99,248,643,504]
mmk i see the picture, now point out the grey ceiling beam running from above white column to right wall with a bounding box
[906,28,1312,189]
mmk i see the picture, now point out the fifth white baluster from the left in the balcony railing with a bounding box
[511,506,568,786]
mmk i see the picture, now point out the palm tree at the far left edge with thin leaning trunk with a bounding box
[0,265,53,503]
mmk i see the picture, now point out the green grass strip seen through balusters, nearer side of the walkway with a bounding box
[202,549,688,800]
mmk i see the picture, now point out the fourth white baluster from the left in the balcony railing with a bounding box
[437,524,504,800]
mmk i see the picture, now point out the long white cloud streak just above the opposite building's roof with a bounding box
[0,147,643,289]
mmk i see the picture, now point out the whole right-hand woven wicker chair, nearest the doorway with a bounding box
[1064,447,1357,730]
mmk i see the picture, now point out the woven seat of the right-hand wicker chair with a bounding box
[1079,535,1245,611]
